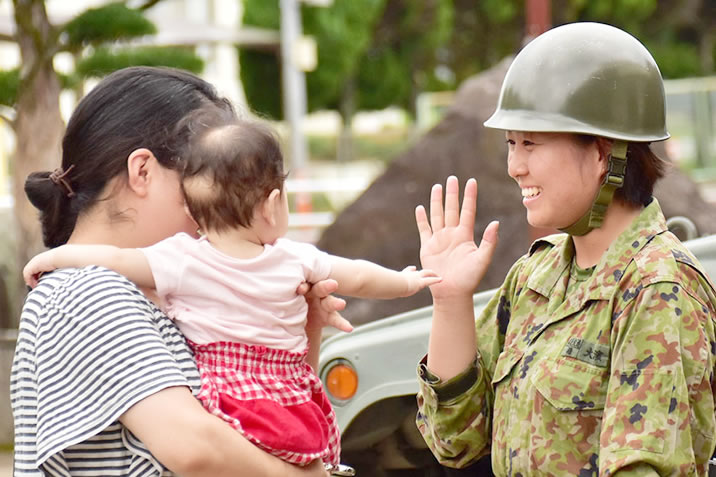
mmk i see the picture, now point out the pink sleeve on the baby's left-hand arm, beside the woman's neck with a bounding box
[140,233,196,297]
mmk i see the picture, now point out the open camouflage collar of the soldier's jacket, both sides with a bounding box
[527,198,667,301]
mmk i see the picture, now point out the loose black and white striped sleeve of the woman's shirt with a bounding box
[28,267,189,463]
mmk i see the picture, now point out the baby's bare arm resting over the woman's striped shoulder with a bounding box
[22,245,155,288]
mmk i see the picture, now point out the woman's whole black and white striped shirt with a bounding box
[10,266,199,477]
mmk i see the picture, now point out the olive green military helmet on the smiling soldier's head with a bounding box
[485,22,669,142]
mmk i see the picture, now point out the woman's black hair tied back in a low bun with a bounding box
[25,67,233,247]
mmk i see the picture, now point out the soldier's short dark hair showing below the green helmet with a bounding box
[577,134,667,207]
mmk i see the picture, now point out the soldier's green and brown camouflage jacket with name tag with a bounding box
[417,199,716,477]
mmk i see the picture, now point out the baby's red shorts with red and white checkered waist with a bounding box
[189,341,340,465]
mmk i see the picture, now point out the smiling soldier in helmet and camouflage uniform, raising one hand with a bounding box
[416,23,716,476]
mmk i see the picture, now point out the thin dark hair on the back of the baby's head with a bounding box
[178,108,286,231]
